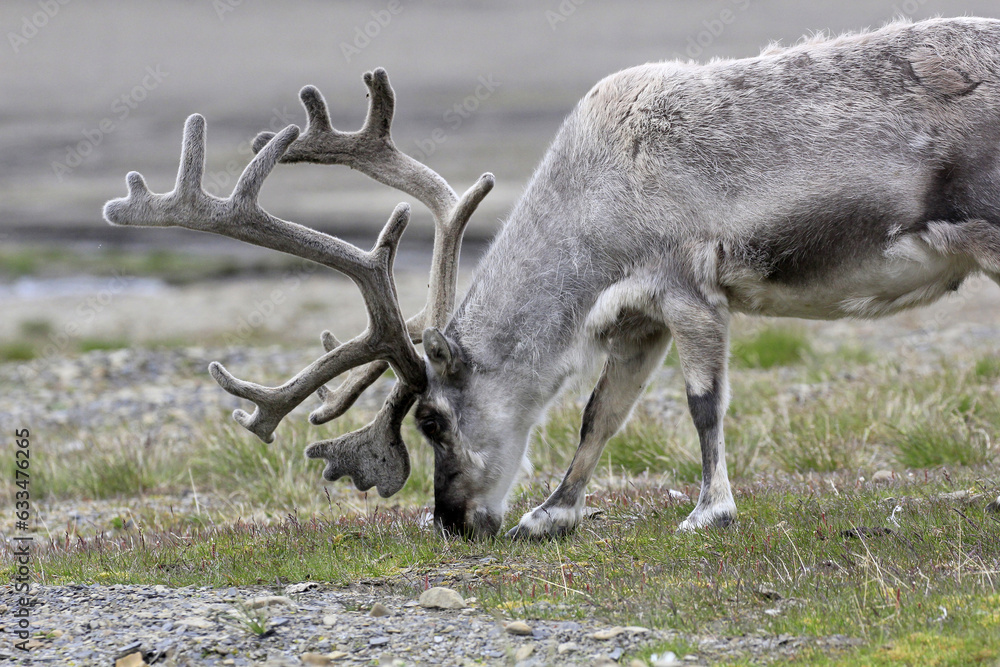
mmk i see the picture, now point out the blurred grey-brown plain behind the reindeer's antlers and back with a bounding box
[0,0,1000,360]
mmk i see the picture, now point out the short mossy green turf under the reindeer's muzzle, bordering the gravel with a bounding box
[11,471,1000,664]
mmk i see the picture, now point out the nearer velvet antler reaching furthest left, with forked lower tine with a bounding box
[104,114,427,442]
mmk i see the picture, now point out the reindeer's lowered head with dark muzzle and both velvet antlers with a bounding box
[104,69,504,534]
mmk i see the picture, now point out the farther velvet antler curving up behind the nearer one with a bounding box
[253,68,494,424]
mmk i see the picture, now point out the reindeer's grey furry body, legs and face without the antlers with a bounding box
[417,18,1000,537]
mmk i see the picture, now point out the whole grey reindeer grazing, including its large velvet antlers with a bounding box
[105,18,1000,537]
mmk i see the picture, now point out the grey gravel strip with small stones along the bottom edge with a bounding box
[0,583,856,667]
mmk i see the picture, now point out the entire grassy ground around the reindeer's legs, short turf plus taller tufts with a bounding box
[7,332,1000,665]
